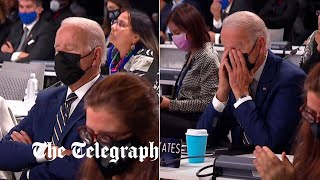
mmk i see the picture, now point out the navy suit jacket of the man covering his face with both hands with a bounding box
[197,51,305,152]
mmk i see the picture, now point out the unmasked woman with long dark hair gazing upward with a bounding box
[106,9,159,88]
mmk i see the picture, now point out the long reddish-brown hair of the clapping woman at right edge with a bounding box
[293,64,320,179]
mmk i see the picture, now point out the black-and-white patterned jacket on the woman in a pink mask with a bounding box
[169,42,220,112]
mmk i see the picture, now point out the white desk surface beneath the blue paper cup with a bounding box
[160,154,293,180]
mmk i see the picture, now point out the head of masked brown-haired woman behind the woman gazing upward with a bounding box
[101,0,131,39]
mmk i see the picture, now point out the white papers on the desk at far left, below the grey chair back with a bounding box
[6,100,34,117]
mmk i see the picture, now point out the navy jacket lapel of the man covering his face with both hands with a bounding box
[255,51,277,107]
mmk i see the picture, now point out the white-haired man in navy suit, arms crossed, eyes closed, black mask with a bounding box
[0,17,105,179]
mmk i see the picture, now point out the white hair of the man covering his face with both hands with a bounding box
[222,11,270,49]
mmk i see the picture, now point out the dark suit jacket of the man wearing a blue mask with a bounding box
[0,15,55,62]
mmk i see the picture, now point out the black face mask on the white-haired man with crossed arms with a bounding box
[54,50,93,86]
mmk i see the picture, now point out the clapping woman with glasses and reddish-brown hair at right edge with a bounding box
[253,65,320,180]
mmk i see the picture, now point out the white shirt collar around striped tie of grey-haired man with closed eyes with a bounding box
[66,74,100,117]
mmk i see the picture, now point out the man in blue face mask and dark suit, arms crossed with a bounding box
[0,0,55,62]
